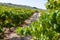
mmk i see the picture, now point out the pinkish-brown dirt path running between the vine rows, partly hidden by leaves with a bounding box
[4,13,40,40]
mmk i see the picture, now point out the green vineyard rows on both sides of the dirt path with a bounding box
[0,0,60,40]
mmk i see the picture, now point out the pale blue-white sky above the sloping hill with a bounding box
[0,0,47,9]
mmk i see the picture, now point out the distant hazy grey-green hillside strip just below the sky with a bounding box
[0,3,40,10]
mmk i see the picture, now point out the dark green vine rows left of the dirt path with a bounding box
[0,6,35,27]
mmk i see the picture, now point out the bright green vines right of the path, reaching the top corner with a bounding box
[16,0,60,40]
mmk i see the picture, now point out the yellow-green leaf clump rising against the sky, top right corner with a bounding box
[46,0,60,9]
